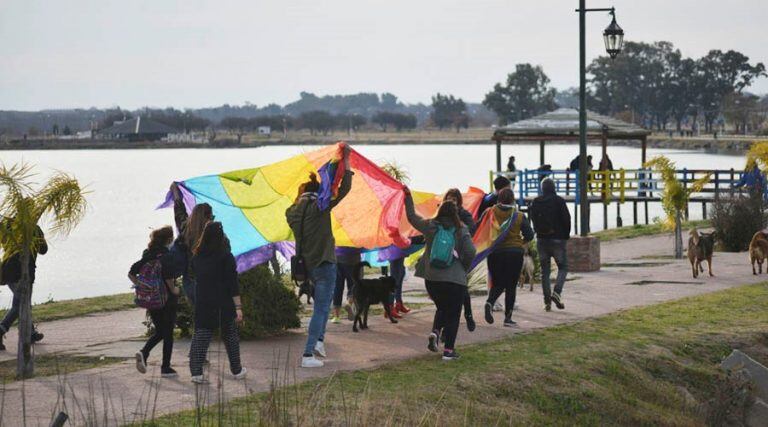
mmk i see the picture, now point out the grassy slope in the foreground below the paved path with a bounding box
[148,283,768,426]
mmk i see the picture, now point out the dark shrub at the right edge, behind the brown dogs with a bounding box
[712,191,766,252]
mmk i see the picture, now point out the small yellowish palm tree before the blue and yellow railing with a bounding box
[644,156,710,259]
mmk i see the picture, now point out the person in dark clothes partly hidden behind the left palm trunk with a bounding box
[0,222,48,351]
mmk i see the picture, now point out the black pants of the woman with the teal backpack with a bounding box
[426,280,467,350]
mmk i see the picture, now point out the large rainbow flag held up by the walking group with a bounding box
[159,143,482,272]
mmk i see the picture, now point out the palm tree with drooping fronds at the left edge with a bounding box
[0,164,86,378]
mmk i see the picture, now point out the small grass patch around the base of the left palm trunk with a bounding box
[0,354,125,383]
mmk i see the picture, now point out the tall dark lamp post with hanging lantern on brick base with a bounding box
[576,0,624,236]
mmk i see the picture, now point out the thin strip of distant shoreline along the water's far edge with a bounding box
[0,132,759,154]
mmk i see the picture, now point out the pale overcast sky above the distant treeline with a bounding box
[0,0,768,110]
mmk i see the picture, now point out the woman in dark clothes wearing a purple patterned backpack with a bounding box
[128,225,180,378]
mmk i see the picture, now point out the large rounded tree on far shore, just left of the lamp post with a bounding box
[483,64,556,124]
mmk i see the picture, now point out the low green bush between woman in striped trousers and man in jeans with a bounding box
[240,265,301,338]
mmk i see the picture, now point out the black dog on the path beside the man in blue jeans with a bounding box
[352,262,397,332]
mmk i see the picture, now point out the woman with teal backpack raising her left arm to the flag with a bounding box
[403,187,475,361]
